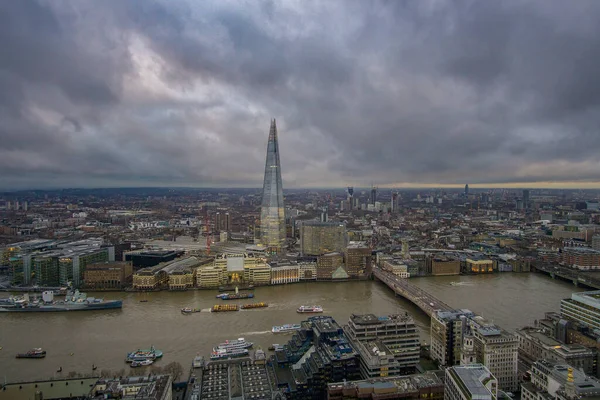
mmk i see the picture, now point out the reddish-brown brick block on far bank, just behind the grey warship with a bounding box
[83,261,133,289]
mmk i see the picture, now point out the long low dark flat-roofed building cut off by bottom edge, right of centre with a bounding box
[327,372,444,400]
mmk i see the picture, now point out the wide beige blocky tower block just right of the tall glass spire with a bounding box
[300,221,346,256]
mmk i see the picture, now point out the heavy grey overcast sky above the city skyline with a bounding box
[0,0,600,189]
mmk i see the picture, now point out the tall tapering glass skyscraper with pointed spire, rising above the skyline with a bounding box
[260,119,285,254]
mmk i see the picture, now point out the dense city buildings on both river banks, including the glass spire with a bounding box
[0,120,600,400]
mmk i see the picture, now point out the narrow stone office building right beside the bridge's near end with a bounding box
[430,310,475,366]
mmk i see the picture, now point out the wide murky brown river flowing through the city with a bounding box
[0,273,582,382]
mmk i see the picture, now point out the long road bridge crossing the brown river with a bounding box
[373,268,454,317]
